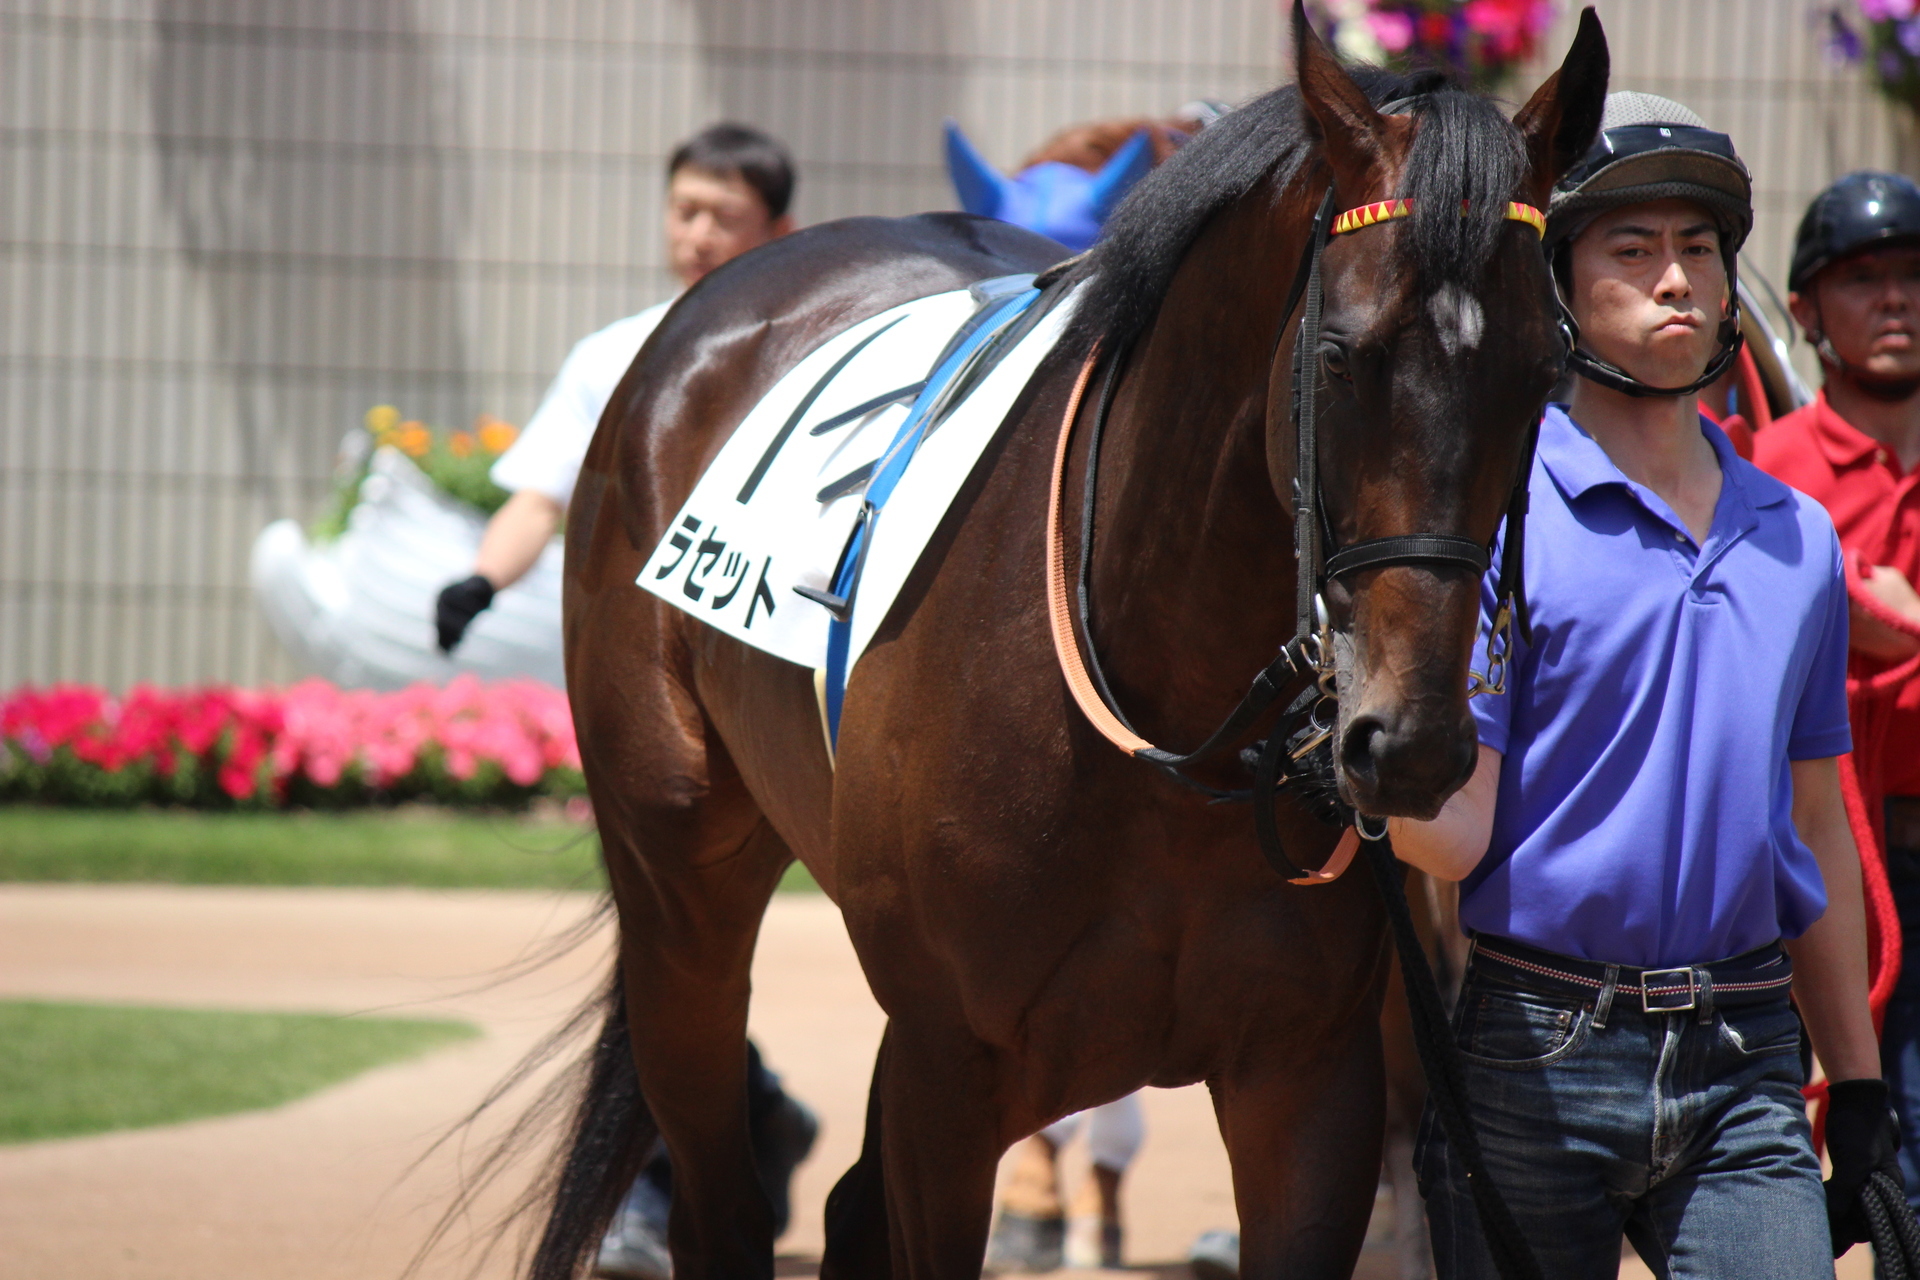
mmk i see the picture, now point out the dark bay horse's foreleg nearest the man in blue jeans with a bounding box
[1213,1019,1384,1280]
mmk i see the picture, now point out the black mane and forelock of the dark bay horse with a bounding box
[1071,67,1526,351]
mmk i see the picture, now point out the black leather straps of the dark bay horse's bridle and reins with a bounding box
[1075,184,1540,879]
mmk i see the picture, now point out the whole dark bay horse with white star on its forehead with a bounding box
[532,6,1607,1280]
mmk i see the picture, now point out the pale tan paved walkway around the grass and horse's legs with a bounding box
[0,885,1868,1280]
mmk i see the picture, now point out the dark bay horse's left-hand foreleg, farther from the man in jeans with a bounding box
[877,1021,1006,1280]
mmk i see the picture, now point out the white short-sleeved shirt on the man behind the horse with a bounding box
[488,297,674,507]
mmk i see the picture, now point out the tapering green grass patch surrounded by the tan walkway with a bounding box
[0,1000,480,1142]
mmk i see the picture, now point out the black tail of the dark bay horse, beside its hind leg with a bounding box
[526,961,659,1280]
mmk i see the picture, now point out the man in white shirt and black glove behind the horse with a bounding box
[434,125,820,1280]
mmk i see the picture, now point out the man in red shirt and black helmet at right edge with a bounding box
[1753,173,1920,1197]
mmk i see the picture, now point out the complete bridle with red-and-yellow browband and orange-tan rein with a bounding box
[1046,184,1546,885]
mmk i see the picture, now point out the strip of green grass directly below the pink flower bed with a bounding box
[0,806,818,892]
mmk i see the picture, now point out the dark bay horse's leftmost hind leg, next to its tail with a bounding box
[595,756,791,1280]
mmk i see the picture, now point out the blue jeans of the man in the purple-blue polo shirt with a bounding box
[1415,948,1834,1280]
